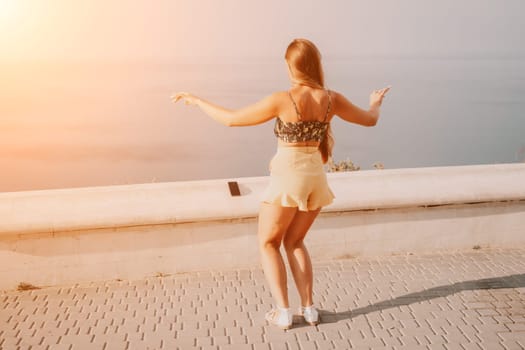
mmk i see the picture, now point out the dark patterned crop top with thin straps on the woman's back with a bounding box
[273,91,332,143]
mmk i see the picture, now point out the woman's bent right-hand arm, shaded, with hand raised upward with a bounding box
[334,87,390,126]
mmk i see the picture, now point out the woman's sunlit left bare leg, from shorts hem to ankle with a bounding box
[258,203,297,308]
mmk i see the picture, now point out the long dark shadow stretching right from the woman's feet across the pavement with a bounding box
[319,274,525,323]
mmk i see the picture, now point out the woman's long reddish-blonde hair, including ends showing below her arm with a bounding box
[284,39,334,163]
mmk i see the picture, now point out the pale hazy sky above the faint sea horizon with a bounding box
[0,0,525,60]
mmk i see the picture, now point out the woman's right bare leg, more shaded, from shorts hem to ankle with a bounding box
[284,209,321,307]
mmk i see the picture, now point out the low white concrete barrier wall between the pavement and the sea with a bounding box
[0,164,525,289]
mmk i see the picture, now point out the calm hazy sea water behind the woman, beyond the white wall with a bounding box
[0,57,525,192]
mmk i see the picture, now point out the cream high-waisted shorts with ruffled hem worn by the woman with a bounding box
[262,147,335,211]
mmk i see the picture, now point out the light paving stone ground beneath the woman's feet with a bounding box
[0,248,525,350]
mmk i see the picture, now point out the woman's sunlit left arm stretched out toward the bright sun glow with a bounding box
[171,92,279,126]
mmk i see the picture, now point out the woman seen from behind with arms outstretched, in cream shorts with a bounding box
[172,39,390,329]
